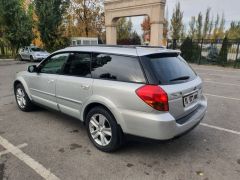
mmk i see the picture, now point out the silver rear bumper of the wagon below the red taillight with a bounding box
[122,96,207,140]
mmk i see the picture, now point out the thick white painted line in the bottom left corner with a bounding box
[0,136,59,180]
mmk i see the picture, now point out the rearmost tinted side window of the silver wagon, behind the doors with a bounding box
[92,54,145,83]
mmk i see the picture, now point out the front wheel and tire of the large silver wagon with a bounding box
[14,83,35,112]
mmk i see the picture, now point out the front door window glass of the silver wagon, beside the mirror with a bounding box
[40,53,69,74]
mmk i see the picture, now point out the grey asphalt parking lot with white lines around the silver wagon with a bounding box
[0,61,240,180]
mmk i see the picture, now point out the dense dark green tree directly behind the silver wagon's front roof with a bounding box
[35,0,69,51]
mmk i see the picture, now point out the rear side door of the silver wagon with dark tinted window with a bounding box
[56,52,93,119]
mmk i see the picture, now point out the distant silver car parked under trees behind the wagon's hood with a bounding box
[17,46,50,62]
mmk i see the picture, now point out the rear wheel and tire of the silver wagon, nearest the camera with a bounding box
[86,106,123,152]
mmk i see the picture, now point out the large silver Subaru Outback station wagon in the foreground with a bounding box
[14,46,207,152]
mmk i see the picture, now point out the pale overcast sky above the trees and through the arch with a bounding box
[132,0,240,34]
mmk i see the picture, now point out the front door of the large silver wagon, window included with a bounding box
[29,53,69,110]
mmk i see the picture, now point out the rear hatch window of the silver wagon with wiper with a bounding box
[144,54,196,85]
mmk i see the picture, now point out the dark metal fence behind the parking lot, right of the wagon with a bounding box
[167,38,240,68]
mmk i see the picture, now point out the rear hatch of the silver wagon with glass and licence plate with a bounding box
[141,53,202,119]
